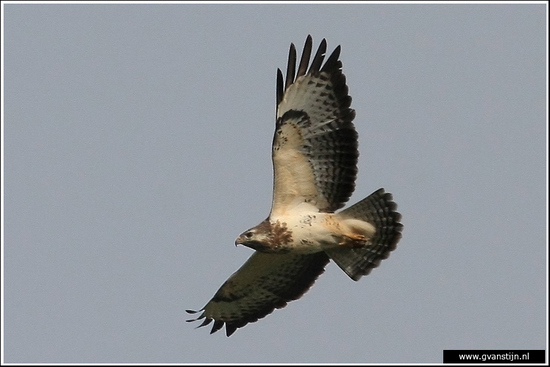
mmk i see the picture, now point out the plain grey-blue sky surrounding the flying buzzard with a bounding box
[3,4,548,363]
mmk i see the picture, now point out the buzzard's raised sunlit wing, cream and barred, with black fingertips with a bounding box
[271,36,359,215]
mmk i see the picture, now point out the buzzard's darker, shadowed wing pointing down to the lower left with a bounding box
[187,251,329,336]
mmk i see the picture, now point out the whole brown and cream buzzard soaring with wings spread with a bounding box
[187,36,403,336]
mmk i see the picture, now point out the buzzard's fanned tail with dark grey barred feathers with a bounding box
[325,189,403,281]
